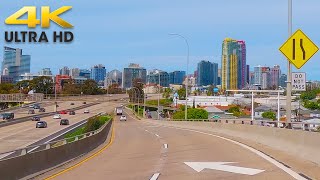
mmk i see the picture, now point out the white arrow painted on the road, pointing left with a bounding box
[184,162,264,175]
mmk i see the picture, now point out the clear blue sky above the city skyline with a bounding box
[0,0,320,80]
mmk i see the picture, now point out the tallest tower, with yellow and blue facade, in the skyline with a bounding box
[221,38,246,90]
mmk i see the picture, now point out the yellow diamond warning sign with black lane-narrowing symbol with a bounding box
[279,29,319,69]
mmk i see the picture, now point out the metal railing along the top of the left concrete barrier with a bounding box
[0,113,112,161]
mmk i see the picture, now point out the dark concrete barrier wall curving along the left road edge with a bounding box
[0,121,112,179]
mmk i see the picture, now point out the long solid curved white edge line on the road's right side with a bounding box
[144,125,307,180]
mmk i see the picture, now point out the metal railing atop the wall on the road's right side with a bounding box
[163,119,320,132]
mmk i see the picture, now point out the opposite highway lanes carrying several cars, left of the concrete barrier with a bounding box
[0,102,118,155]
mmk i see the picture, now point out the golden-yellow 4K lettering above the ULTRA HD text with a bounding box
[5,6,73,28]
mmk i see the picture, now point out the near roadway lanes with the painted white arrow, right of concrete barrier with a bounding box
[38,110,305,180]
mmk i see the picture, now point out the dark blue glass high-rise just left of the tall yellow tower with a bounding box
[197,61,218,86]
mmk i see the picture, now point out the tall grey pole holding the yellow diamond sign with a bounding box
[286,0,292,126]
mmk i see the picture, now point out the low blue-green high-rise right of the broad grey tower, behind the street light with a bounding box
[147,69,169,87]
